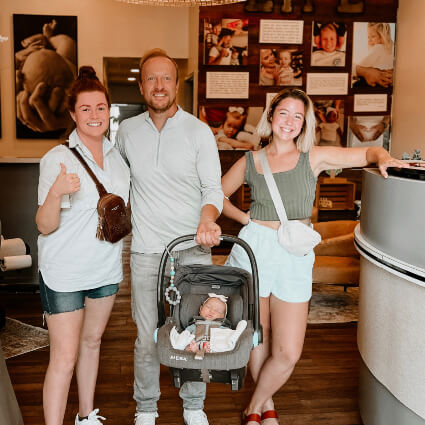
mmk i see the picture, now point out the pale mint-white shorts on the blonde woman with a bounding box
[226,221,315,303]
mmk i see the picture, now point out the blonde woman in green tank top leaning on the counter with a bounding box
[222,88,404,425]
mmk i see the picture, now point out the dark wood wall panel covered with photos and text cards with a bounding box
[199,6,396,150]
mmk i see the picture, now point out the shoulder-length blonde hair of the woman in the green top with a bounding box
[256,88,316,152]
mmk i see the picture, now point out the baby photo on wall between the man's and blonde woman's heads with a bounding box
[199,105,264,150]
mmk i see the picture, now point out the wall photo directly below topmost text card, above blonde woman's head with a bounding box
[259,48,304,86]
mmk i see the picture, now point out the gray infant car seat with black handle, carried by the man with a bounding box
[156,235,261,390]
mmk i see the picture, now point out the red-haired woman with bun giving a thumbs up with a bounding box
[36,66,130,425]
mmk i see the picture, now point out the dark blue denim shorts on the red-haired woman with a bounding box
[40,273,118,314]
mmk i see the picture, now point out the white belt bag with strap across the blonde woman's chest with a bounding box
[258,149,322,257]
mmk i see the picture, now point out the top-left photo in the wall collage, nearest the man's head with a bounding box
[204,18,248,66]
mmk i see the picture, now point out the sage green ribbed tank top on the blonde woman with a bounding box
[245,151,317,221]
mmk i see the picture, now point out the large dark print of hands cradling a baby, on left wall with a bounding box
[13,14,78,139]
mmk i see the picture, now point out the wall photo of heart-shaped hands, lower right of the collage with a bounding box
[347,115,391,151]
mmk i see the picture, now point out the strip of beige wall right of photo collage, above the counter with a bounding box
[391,0,425,158]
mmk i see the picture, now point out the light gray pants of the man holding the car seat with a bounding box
[130,245,211,412]
